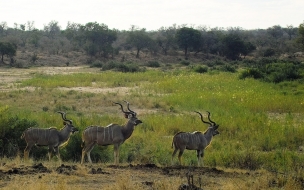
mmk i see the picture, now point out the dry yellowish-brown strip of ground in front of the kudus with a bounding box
[0,163,276,189]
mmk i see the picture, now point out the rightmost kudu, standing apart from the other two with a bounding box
[172,111,220,166]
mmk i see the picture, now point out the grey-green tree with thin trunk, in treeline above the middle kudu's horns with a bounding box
[127,28,153,58]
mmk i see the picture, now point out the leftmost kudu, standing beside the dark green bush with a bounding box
[21,111,78,160]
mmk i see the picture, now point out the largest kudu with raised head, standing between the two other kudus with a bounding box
[81,101,142,164]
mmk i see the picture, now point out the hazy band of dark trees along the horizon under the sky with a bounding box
[0,21,304,66]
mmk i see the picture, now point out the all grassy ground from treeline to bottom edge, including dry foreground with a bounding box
[0,66,304,189]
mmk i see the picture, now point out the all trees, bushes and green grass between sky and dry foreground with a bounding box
[0,21,304,189]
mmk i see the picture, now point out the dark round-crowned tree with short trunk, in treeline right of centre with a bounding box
[176,27,201,59]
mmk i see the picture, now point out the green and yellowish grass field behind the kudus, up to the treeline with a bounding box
[0,67,304,189]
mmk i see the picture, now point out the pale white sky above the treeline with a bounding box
[0,0,304,31]
